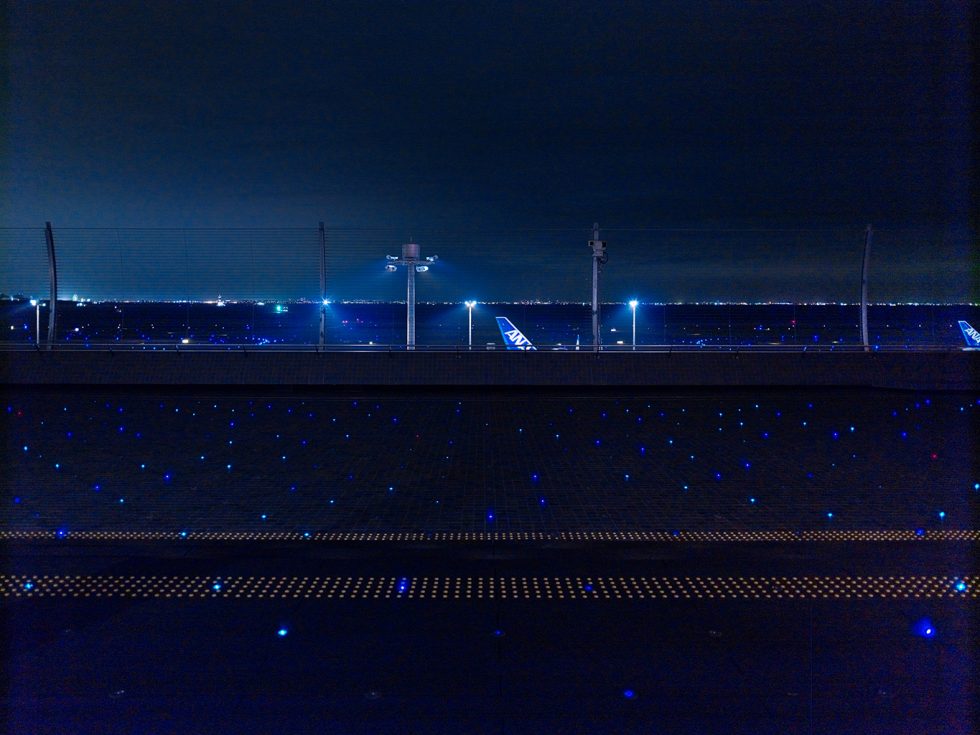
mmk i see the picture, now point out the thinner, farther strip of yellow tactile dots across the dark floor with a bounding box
[0,529,980,542]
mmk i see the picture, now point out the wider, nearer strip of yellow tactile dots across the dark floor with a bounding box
[0,575,980,600]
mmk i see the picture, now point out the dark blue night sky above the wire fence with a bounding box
[0,0,976,300]
